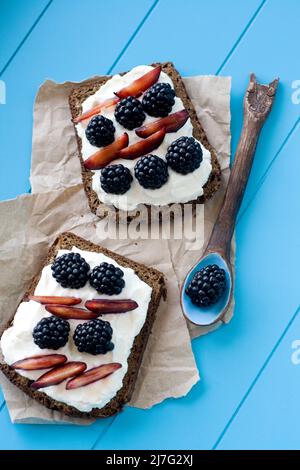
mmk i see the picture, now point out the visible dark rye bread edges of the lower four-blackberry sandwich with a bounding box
[0,232,166,418]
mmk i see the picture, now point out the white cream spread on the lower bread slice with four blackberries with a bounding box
[1,247,152,412]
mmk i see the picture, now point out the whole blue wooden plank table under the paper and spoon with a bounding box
[0,0,300,449]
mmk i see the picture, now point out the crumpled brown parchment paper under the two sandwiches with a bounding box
[0,76,232,424]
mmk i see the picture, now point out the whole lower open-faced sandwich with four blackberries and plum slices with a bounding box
[0,233,164,418]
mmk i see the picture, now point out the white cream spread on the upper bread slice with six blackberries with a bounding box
[76,65,212,211]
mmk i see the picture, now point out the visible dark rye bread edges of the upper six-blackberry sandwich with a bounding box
[69,62,221,218]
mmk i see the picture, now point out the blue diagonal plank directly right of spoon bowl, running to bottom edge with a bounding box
[97,117,300,449]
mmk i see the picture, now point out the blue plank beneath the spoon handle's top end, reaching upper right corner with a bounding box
[221,0,300,212]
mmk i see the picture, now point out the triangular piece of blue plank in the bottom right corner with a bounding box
[218,304,300,450]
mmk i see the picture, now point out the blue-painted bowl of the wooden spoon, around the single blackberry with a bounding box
[181,252,233,326]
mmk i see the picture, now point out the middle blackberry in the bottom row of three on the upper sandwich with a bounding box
[134,155,169,189]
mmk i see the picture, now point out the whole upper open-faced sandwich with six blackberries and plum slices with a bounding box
[69,62,220,218]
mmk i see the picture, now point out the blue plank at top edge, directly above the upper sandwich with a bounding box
[109,0,262,75]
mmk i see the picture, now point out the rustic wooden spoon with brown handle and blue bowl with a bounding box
[181,73,279,326]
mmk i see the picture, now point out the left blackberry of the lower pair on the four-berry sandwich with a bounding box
[32,317,70,350]
